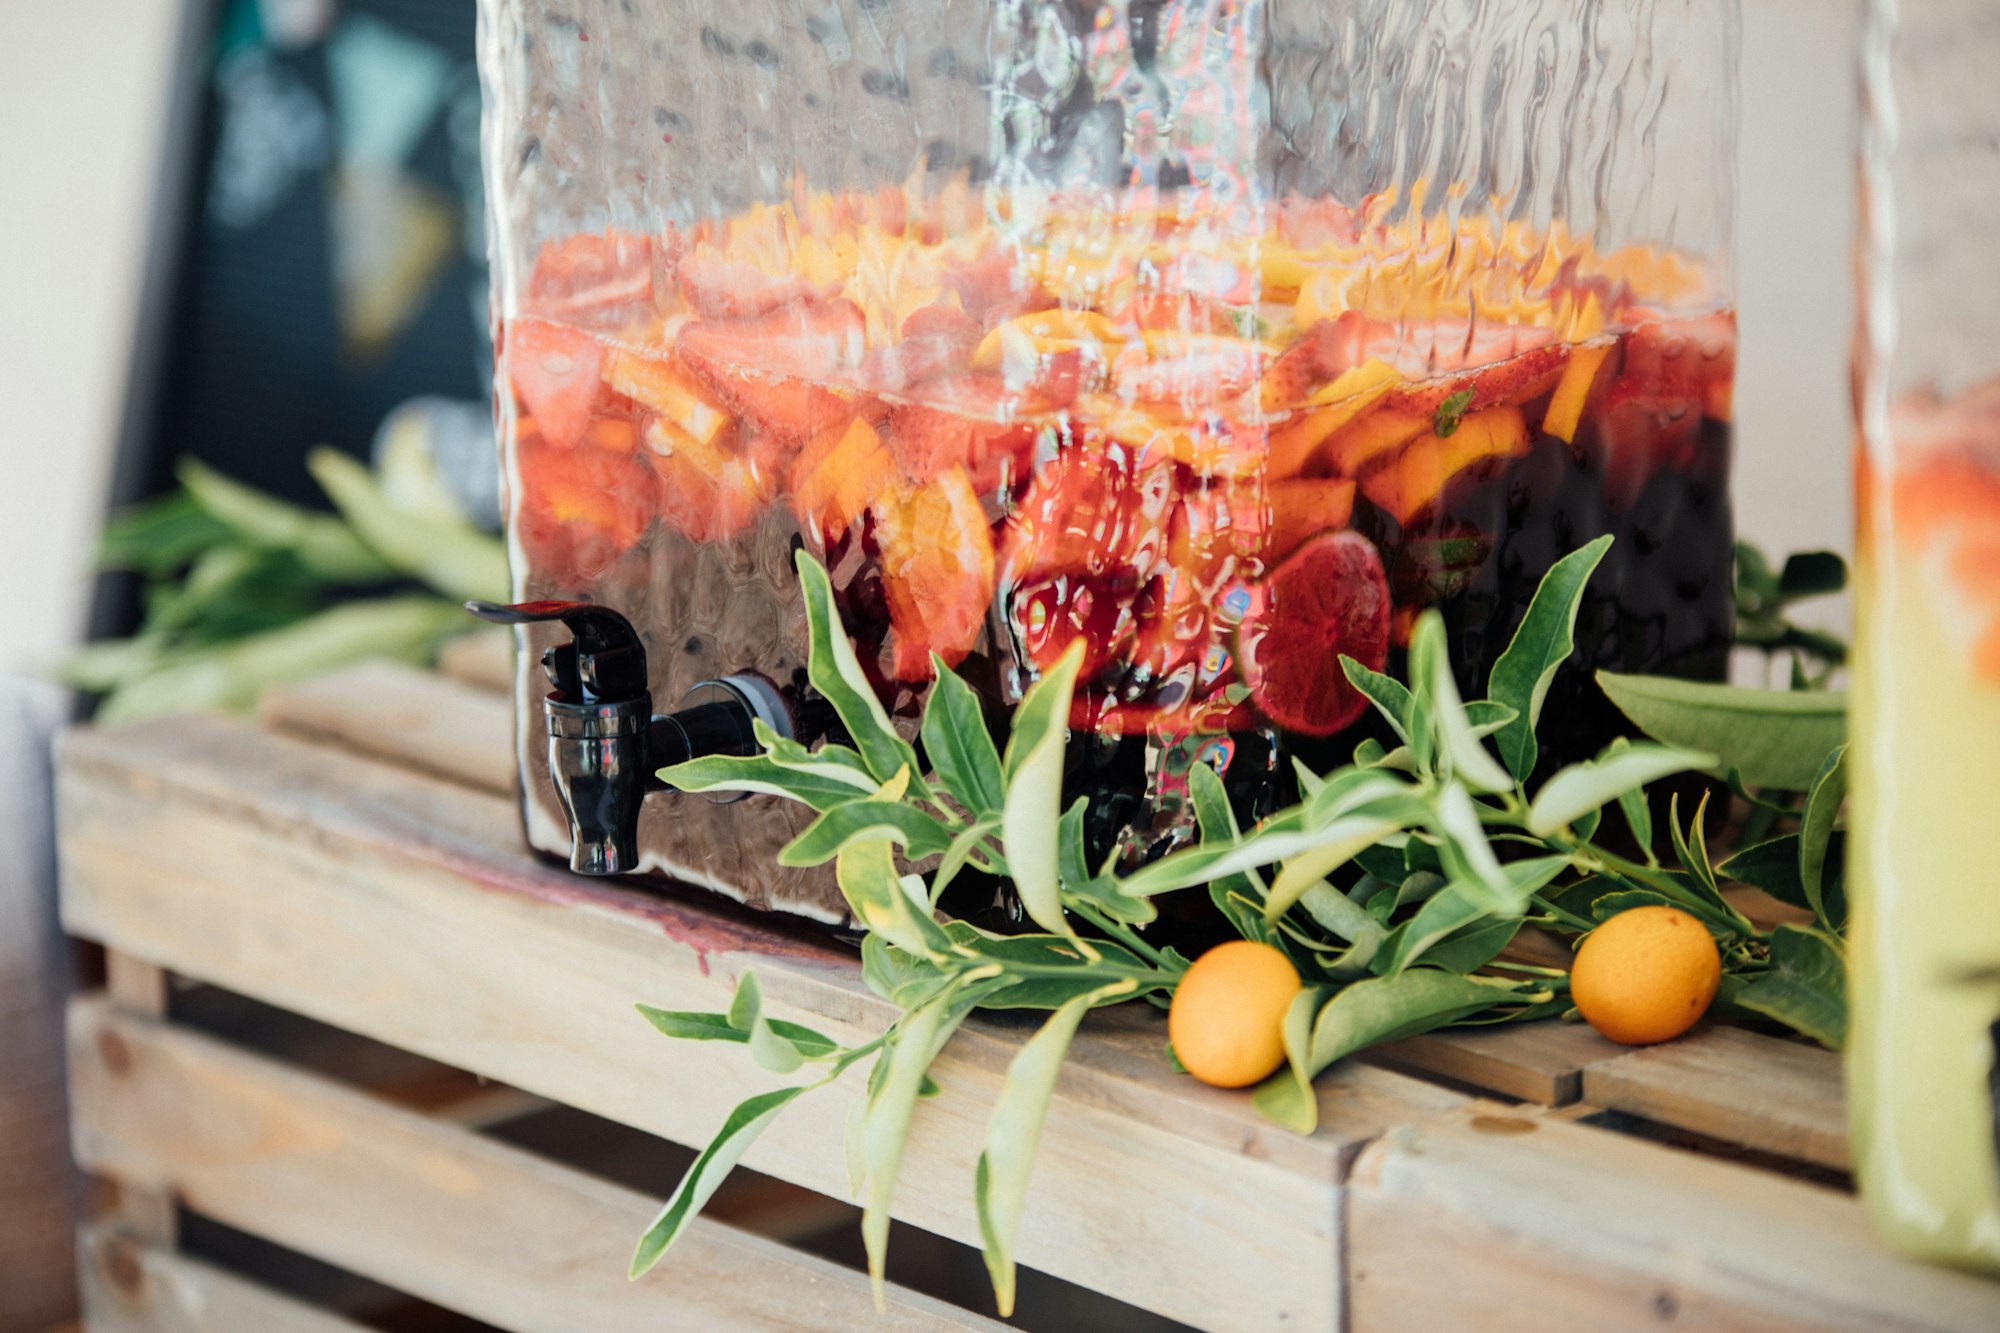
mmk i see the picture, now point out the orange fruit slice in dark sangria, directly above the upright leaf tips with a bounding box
[870,470,994,681]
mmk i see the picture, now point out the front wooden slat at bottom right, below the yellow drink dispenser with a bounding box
[1346,1103,2000,1333]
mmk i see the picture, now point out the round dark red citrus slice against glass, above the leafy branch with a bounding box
[1236,532,1390,737]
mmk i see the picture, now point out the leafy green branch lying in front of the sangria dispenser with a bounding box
[634,538,1844,1313]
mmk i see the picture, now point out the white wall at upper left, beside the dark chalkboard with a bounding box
[0,0,197,673]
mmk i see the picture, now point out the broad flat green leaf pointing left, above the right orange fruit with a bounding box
[1598,671,1848,791]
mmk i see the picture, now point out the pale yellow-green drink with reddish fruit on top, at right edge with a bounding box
[1848,380,2000,1271]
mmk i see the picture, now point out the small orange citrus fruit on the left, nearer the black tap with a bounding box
[1166,939,1300,1087]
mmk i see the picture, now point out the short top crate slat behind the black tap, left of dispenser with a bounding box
[258,662,516,795]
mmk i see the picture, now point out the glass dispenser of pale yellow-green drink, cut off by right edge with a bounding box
[1848,0,2000,1271]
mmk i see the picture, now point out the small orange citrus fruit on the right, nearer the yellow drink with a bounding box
[1570,907,1722,1047]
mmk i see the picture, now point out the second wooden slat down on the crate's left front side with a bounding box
[70,999,1000,1333]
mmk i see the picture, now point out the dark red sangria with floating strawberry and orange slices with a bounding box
[500,186,1734,901]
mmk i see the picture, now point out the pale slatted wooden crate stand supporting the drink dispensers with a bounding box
[58,640,2000,1331]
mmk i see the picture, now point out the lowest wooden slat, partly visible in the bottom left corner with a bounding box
[76,1223,362,1333]
